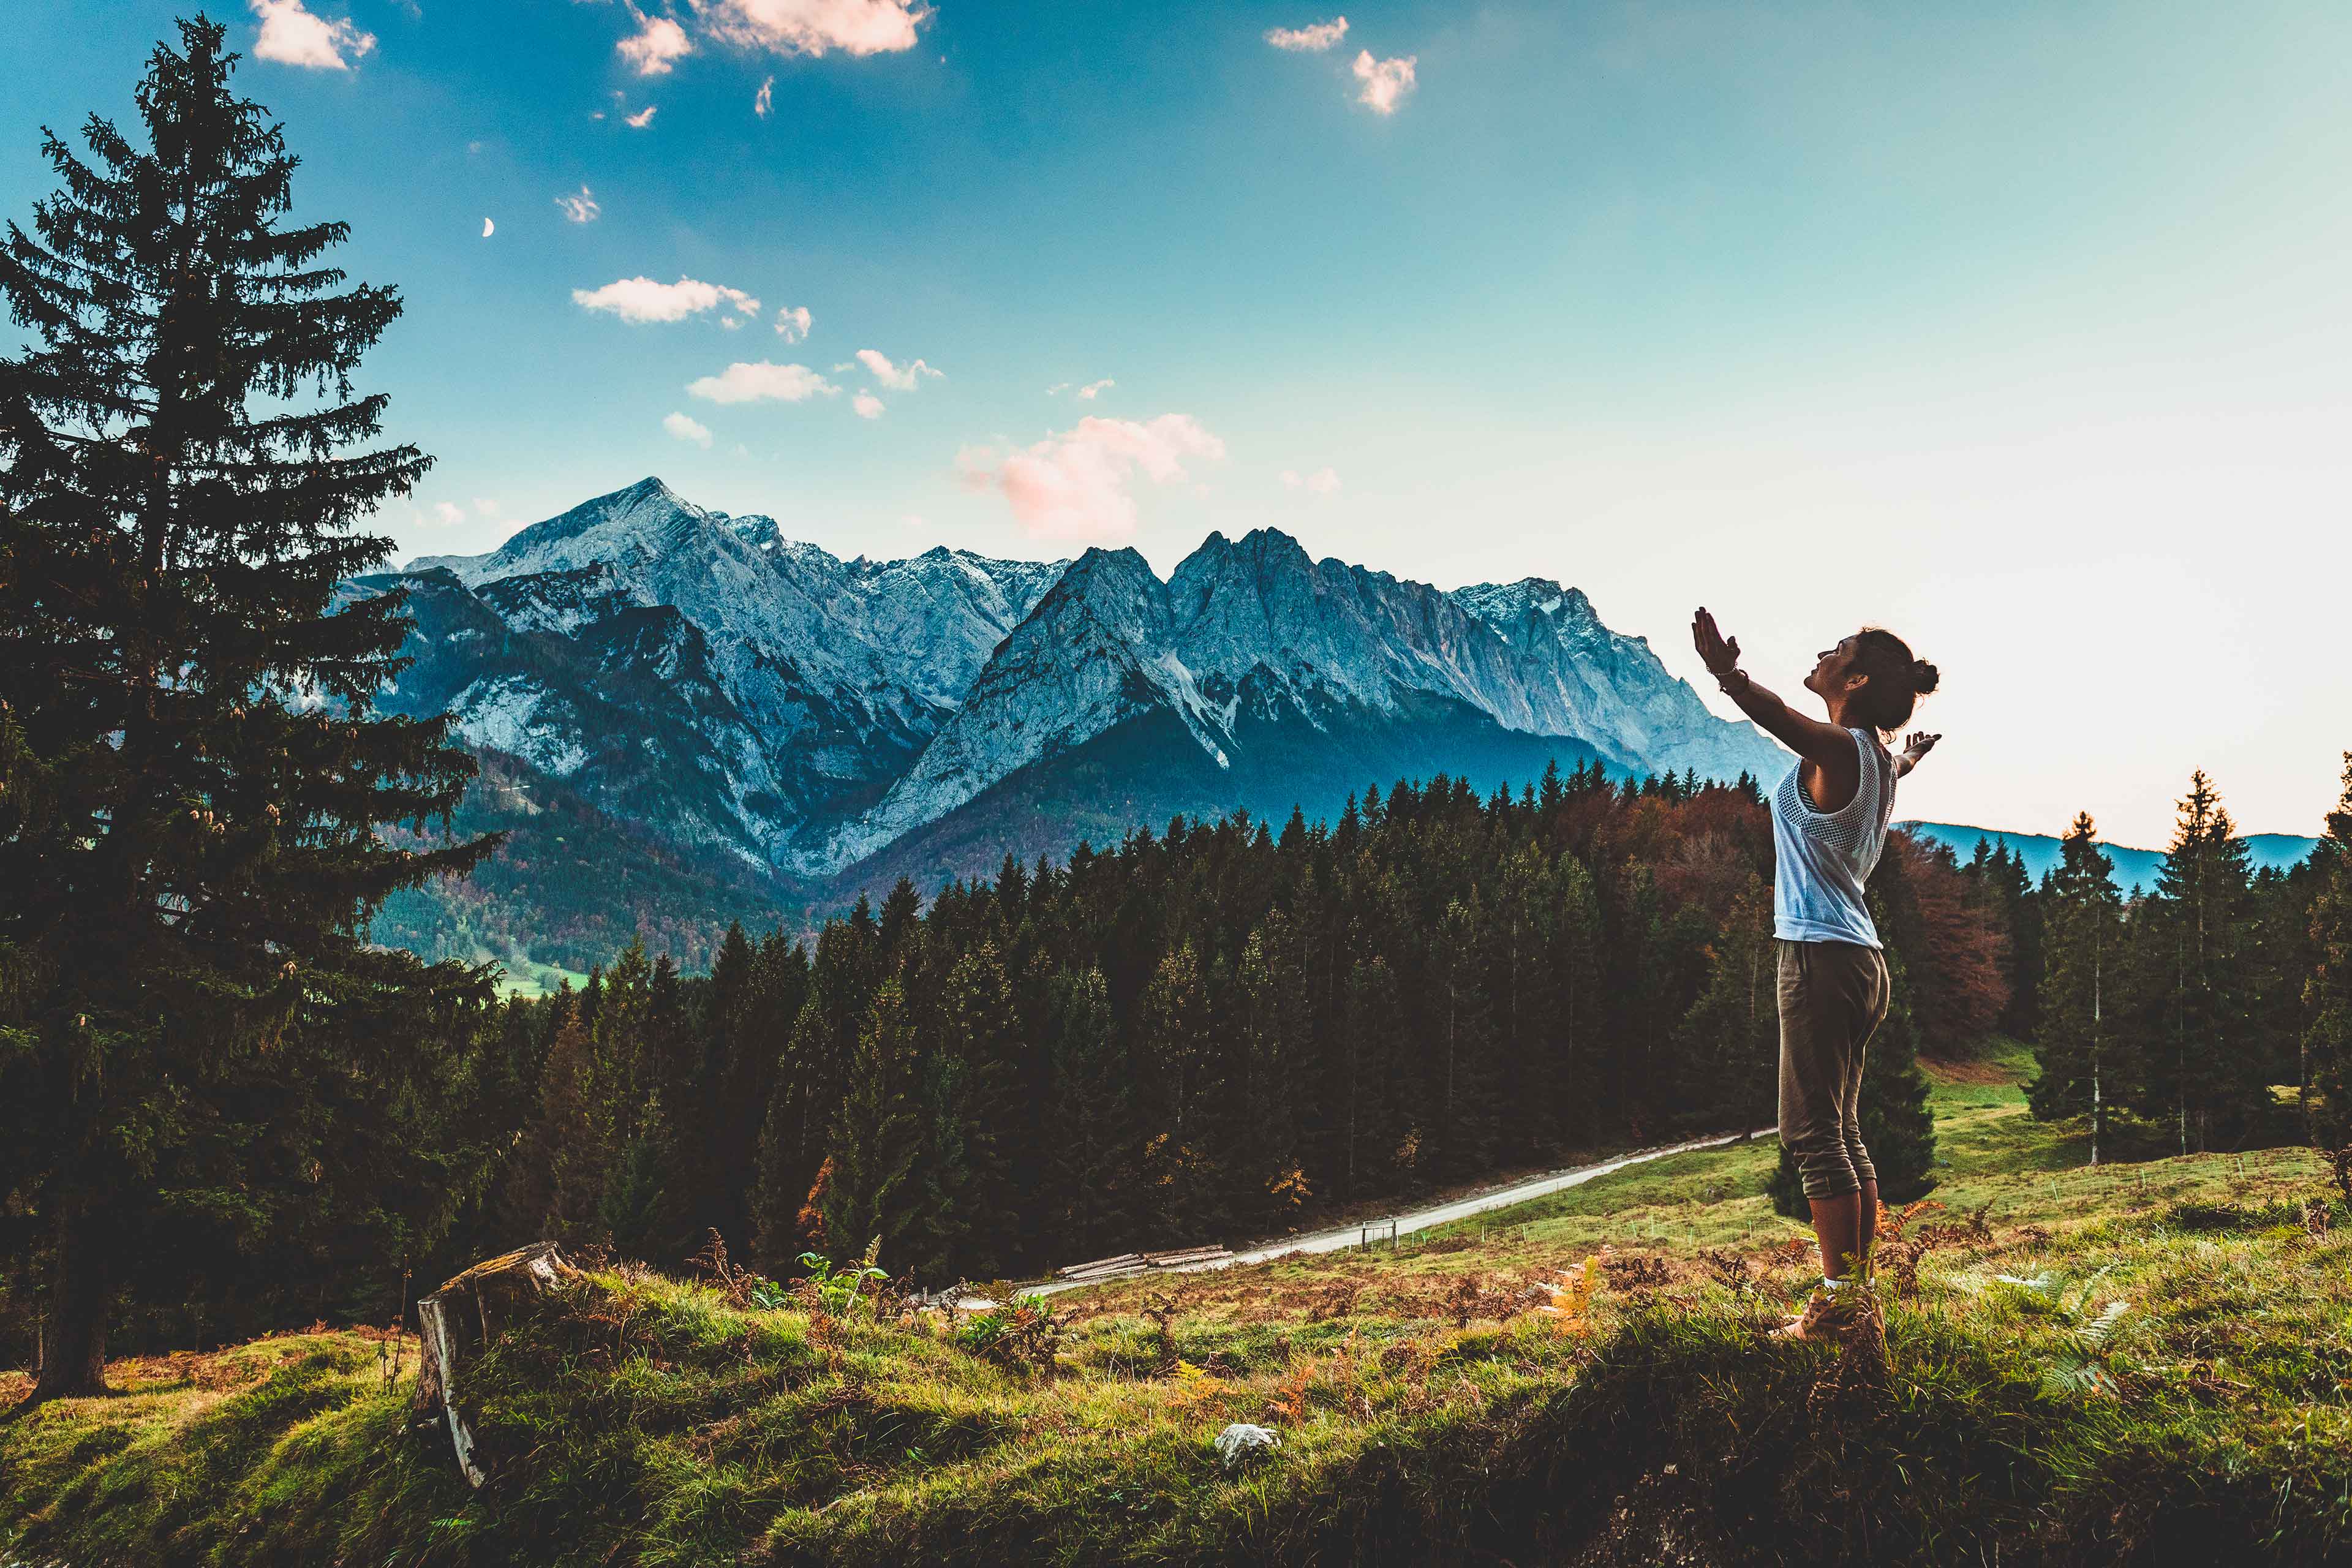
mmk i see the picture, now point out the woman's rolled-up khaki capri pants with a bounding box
[1781,940,1891,1199]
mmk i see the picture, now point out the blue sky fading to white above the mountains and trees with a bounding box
[0,0,2352,844]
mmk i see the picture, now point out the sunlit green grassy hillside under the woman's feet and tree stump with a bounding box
[0,1049,2352,1568]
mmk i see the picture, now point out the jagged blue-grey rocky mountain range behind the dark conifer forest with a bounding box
[350,480,1785,968]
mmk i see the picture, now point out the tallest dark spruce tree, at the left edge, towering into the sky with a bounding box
[0,19,487,1396]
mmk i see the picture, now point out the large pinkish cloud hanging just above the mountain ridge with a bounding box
[955,414,1226,538]
